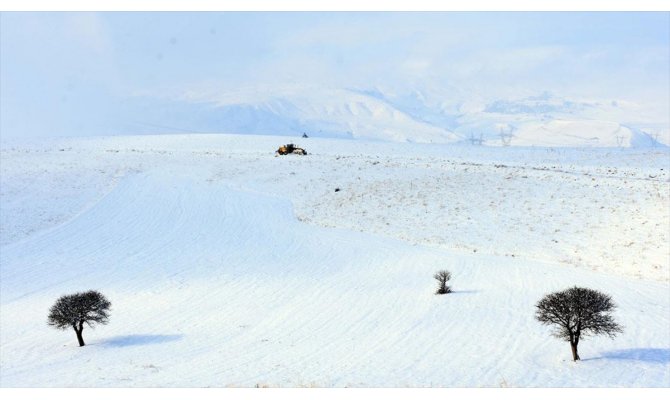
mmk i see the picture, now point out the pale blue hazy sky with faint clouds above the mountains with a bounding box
[0,12,670,137]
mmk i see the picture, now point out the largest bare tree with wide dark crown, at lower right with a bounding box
[535,286,622,361]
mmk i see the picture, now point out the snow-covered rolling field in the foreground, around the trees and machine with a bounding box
[0,135,670,387]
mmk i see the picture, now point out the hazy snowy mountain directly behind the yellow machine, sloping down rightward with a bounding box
[178,86,460,143]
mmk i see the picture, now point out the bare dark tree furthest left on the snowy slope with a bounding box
[47,290,112,346]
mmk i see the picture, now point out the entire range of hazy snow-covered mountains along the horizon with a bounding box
[140,85,670,147]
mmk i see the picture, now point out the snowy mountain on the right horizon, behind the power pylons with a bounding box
[457,93,668,147]
